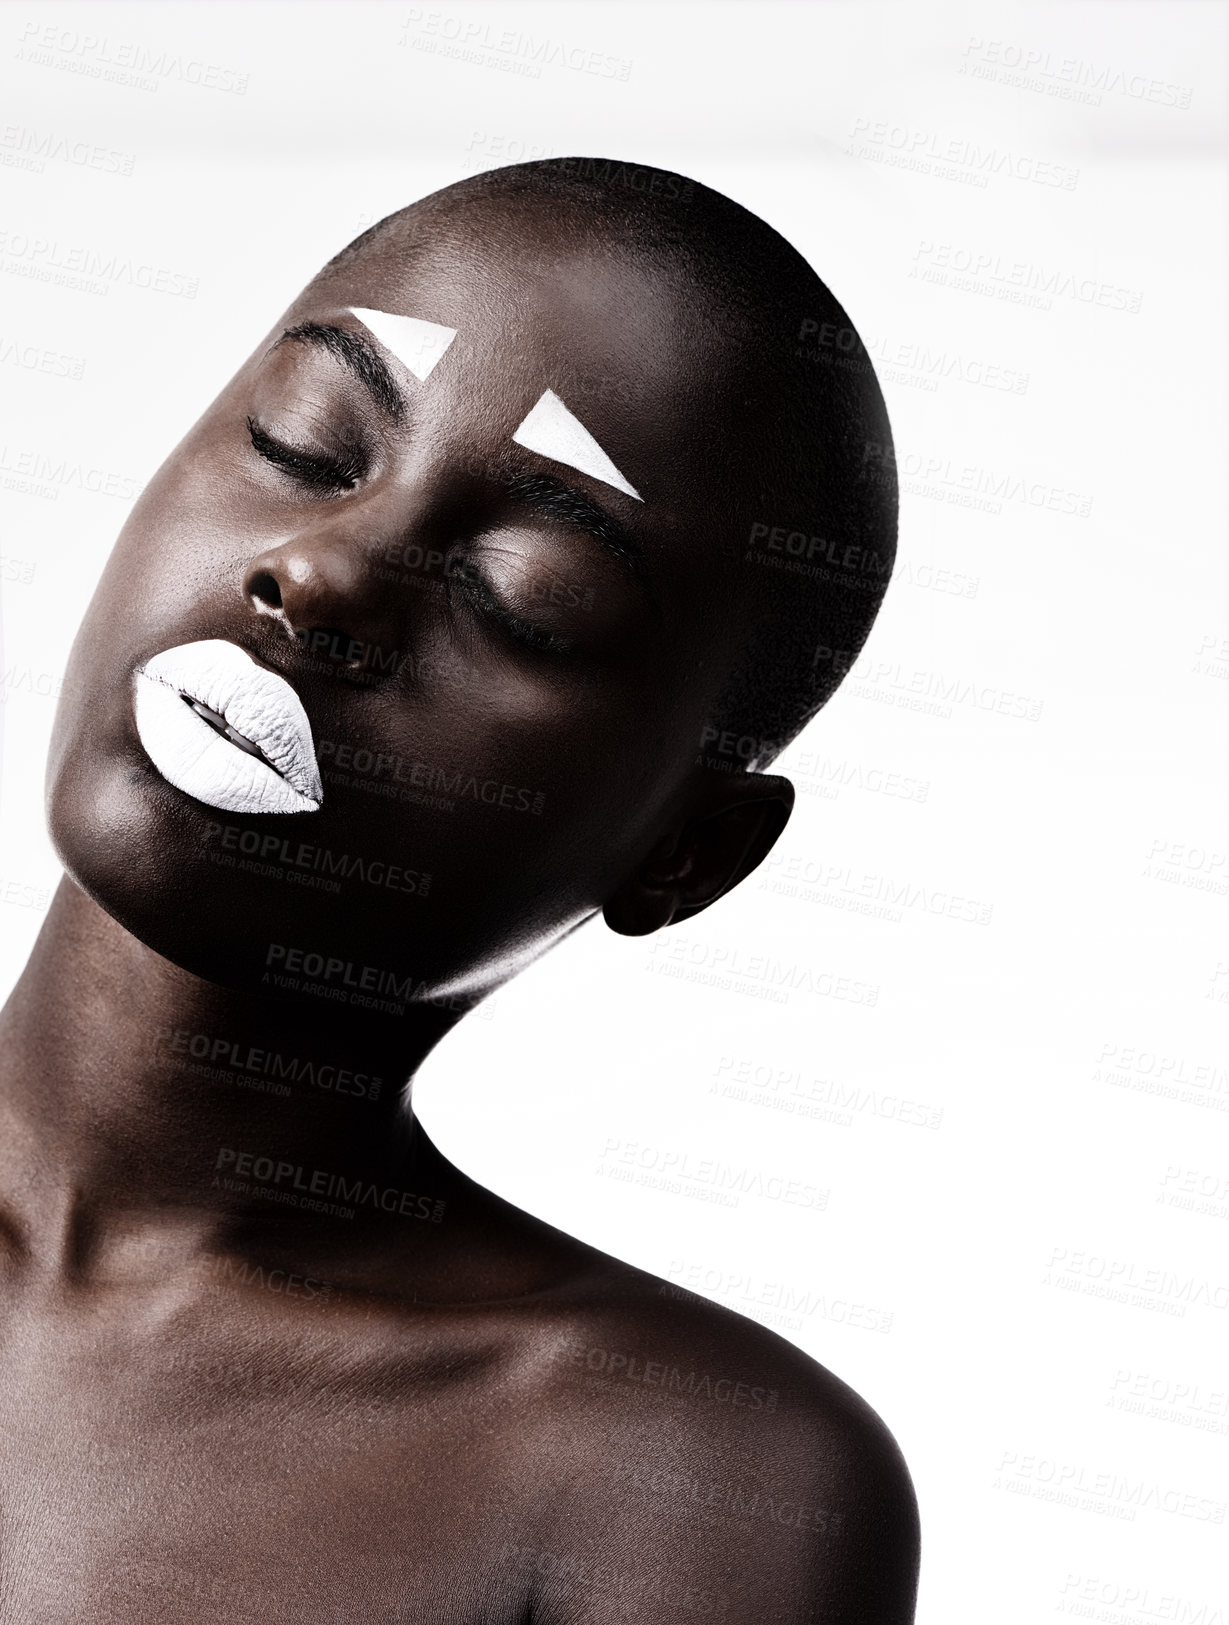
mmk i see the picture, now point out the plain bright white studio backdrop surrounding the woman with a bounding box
[0,0,1229,1625]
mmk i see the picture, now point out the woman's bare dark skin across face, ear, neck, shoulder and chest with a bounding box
[0,193,917,1625]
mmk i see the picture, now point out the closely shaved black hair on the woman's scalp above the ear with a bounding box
[317,158,897,769]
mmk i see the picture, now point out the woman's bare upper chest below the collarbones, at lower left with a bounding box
[0,1306,540,1625]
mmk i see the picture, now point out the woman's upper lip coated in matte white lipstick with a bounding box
[137,637,324,803]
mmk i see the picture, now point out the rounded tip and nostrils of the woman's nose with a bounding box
[244,527,405,673]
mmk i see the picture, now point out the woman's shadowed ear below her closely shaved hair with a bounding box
[601,774,793,936]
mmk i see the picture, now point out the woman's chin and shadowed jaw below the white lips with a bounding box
[47,731,516,1014]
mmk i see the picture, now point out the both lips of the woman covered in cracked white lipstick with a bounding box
[133,637,324,813]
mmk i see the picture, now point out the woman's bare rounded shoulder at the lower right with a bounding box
[520,1259,918,1625]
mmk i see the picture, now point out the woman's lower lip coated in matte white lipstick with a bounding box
[133,671,319,813]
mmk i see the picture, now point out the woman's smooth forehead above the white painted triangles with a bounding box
[302,219,746,522]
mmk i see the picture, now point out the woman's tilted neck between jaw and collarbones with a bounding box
[0,878,463,1271]
